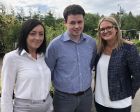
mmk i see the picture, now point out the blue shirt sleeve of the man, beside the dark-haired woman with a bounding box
[45,43,56,79]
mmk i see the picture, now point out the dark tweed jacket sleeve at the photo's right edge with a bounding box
[128,45,140,98]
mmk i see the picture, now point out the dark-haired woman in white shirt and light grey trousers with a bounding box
[1,19,53,112]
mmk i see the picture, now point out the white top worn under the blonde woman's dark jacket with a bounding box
[95,54,132,108]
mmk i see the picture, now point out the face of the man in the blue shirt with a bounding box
[65,14,84,38]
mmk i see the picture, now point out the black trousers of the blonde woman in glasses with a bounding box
[95,102,131,112]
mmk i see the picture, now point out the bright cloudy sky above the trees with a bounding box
[0,0,140,17]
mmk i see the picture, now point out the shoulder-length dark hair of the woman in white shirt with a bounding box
[17,19,46,54]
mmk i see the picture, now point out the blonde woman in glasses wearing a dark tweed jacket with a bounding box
[95,17,140,112]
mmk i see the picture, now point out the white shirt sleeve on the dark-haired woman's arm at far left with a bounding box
[1,54,16,112]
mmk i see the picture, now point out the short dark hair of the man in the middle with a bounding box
[63,4,85,22]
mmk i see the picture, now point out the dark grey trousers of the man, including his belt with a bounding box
[53,88,92,112]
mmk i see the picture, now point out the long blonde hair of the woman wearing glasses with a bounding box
[97,16,124,53]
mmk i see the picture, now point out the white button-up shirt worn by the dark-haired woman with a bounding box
[1,50,51,112]
